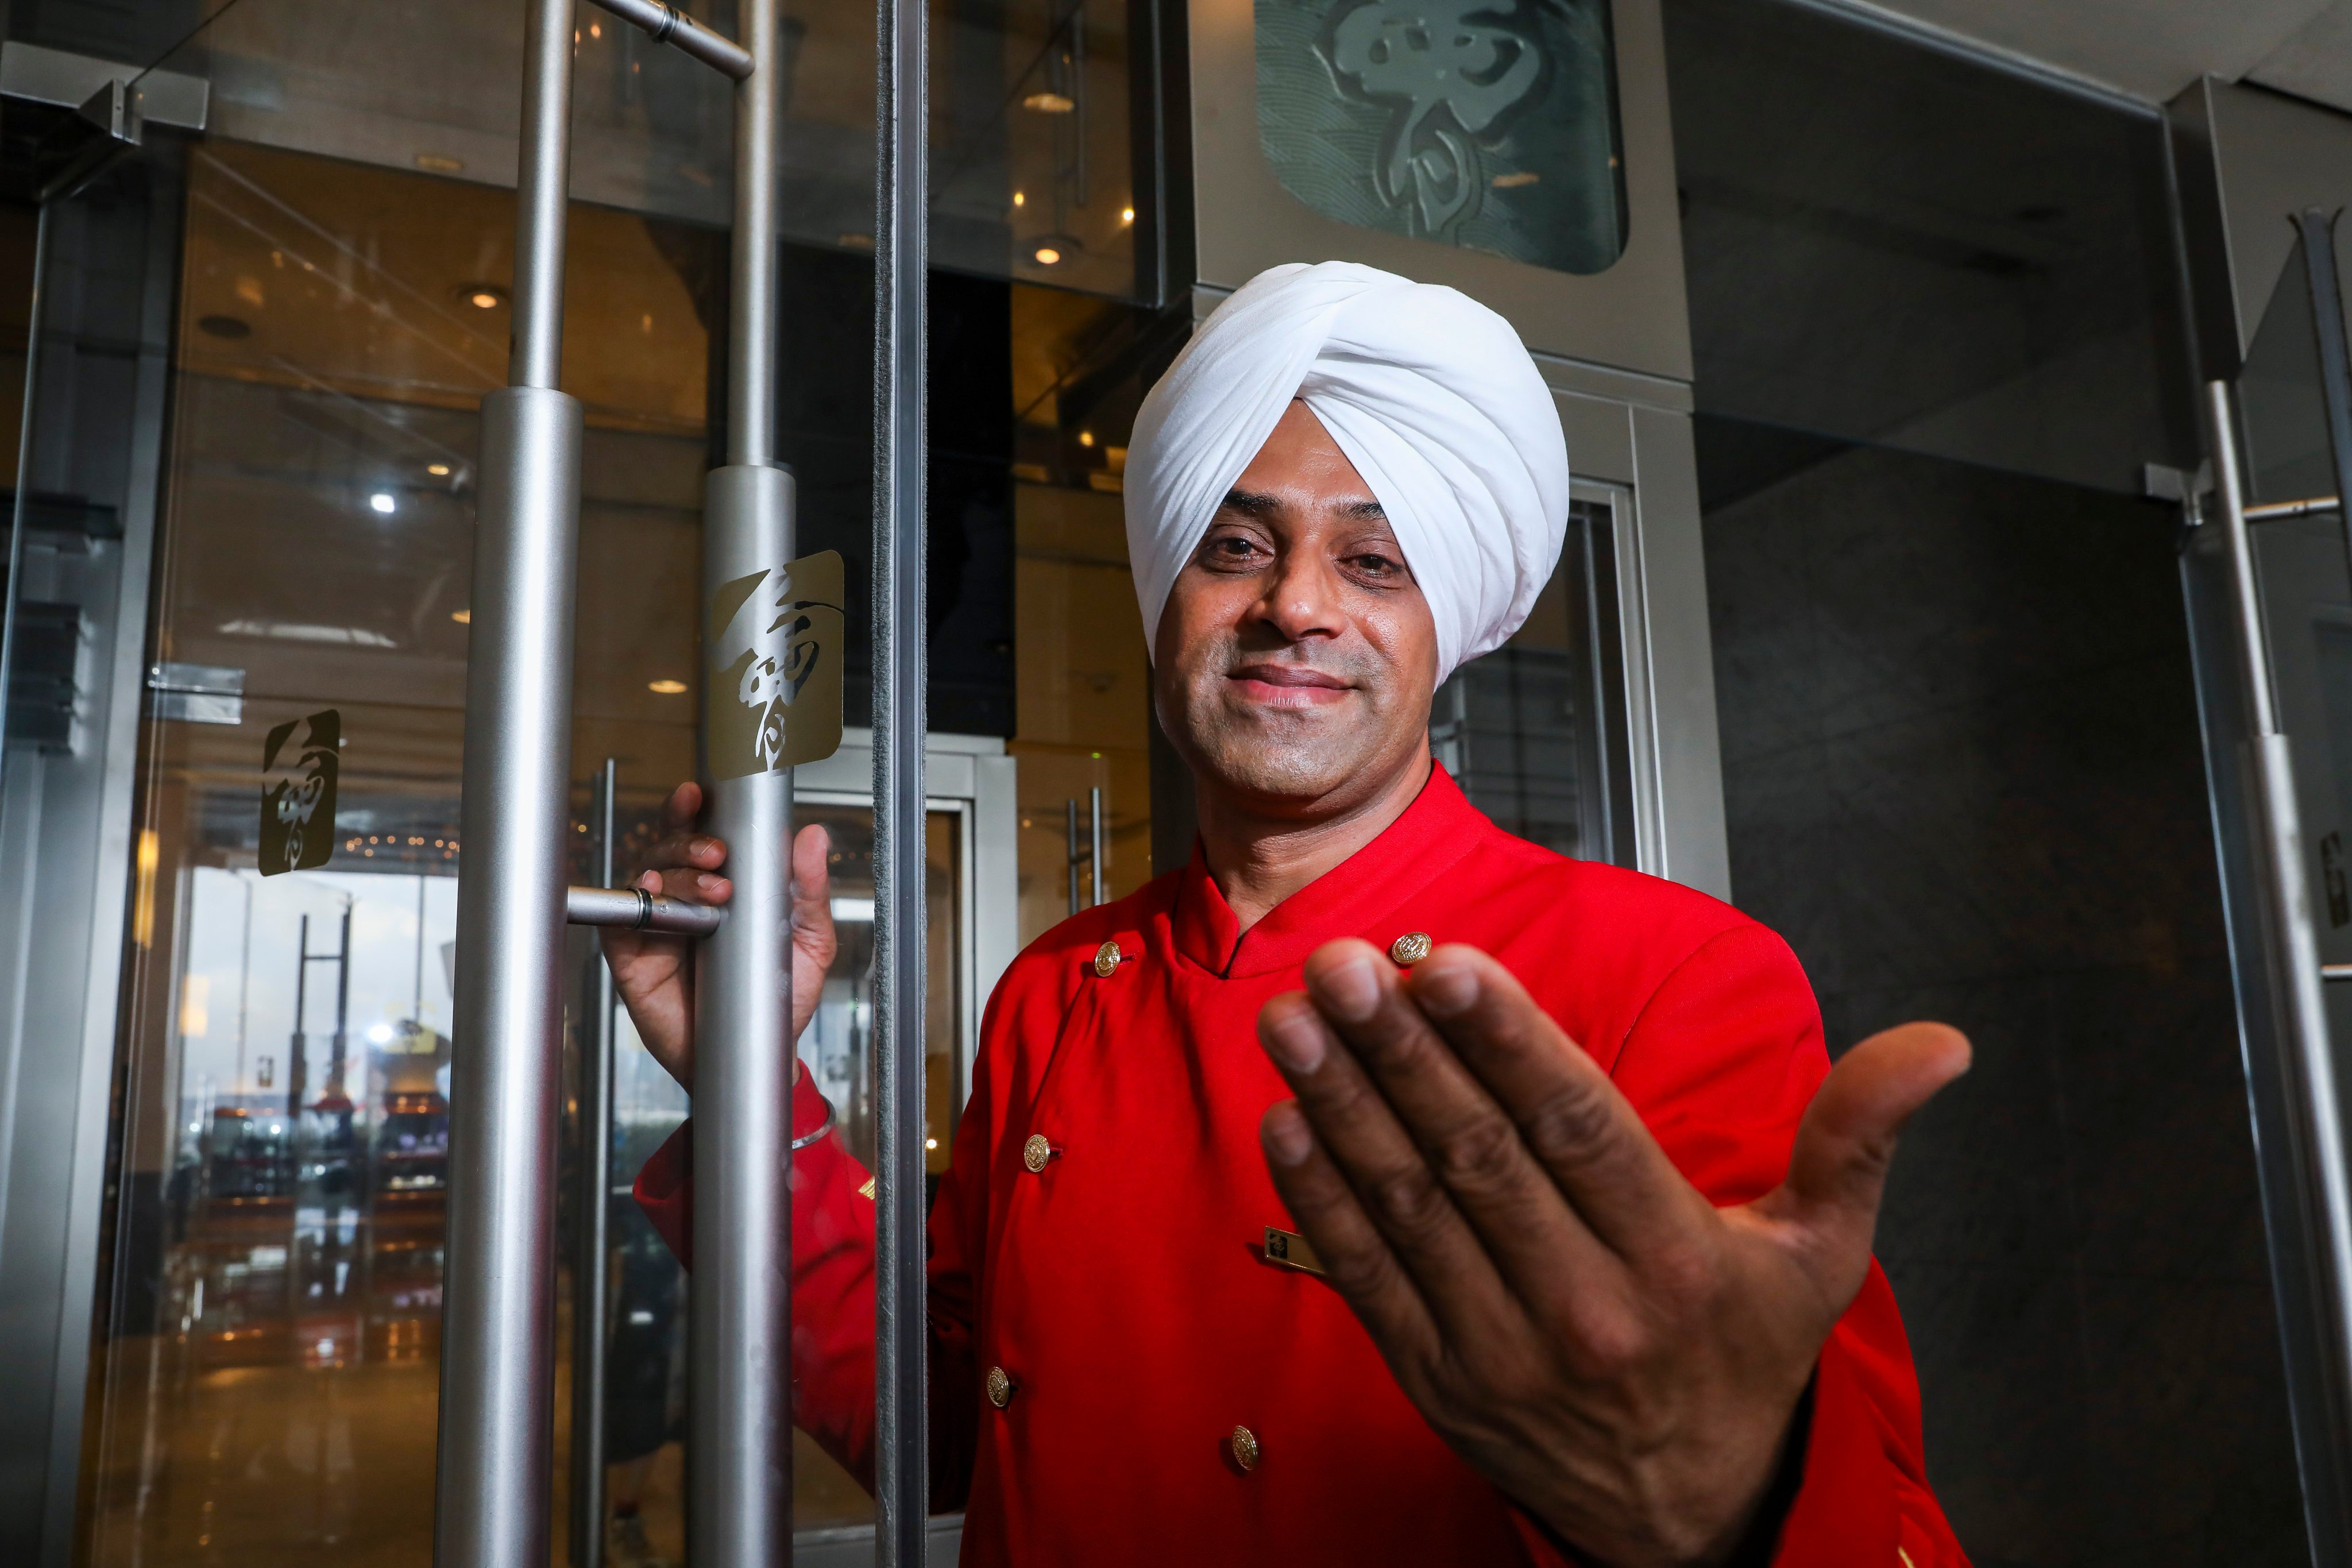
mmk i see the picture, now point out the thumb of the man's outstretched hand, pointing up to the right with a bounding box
[1757,1022,1969,1310]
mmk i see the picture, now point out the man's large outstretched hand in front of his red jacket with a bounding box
[1258,940,1969,1568]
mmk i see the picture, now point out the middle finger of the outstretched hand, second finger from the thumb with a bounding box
[1306,940,1611,1297]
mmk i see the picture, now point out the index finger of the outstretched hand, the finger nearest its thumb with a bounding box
[1407,945,1705,1256]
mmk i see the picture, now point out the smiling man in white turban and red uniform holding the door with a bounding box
[607,263,1966,1568]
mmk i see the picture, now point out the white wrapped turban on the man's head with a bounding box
[1124,261,1569,679]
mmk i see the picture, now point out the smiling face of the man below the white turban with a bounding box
[1153,402,1437,816]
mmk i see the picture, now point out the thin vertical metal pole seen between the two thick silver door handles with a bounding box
[571,757,621,1568]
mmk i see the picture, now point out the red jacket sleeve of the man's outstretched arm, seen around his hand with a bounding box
[1580,924,1969,1568]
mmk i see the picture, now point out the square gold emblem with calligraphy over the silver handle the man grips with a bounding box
[703,550,849,778]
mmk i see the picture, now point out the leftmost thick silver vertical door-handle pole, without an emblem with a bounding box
[432,0,581,1568]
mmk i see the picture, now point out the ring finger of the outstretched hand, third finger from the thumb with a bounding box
[1258,992,1503,1333]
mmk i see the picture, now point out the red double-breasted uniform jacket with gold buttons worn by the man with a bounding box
[638,768,1966,1568]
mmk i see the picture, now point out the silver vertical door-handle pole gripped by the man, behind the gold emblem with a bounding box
[687,0,793,1568]
